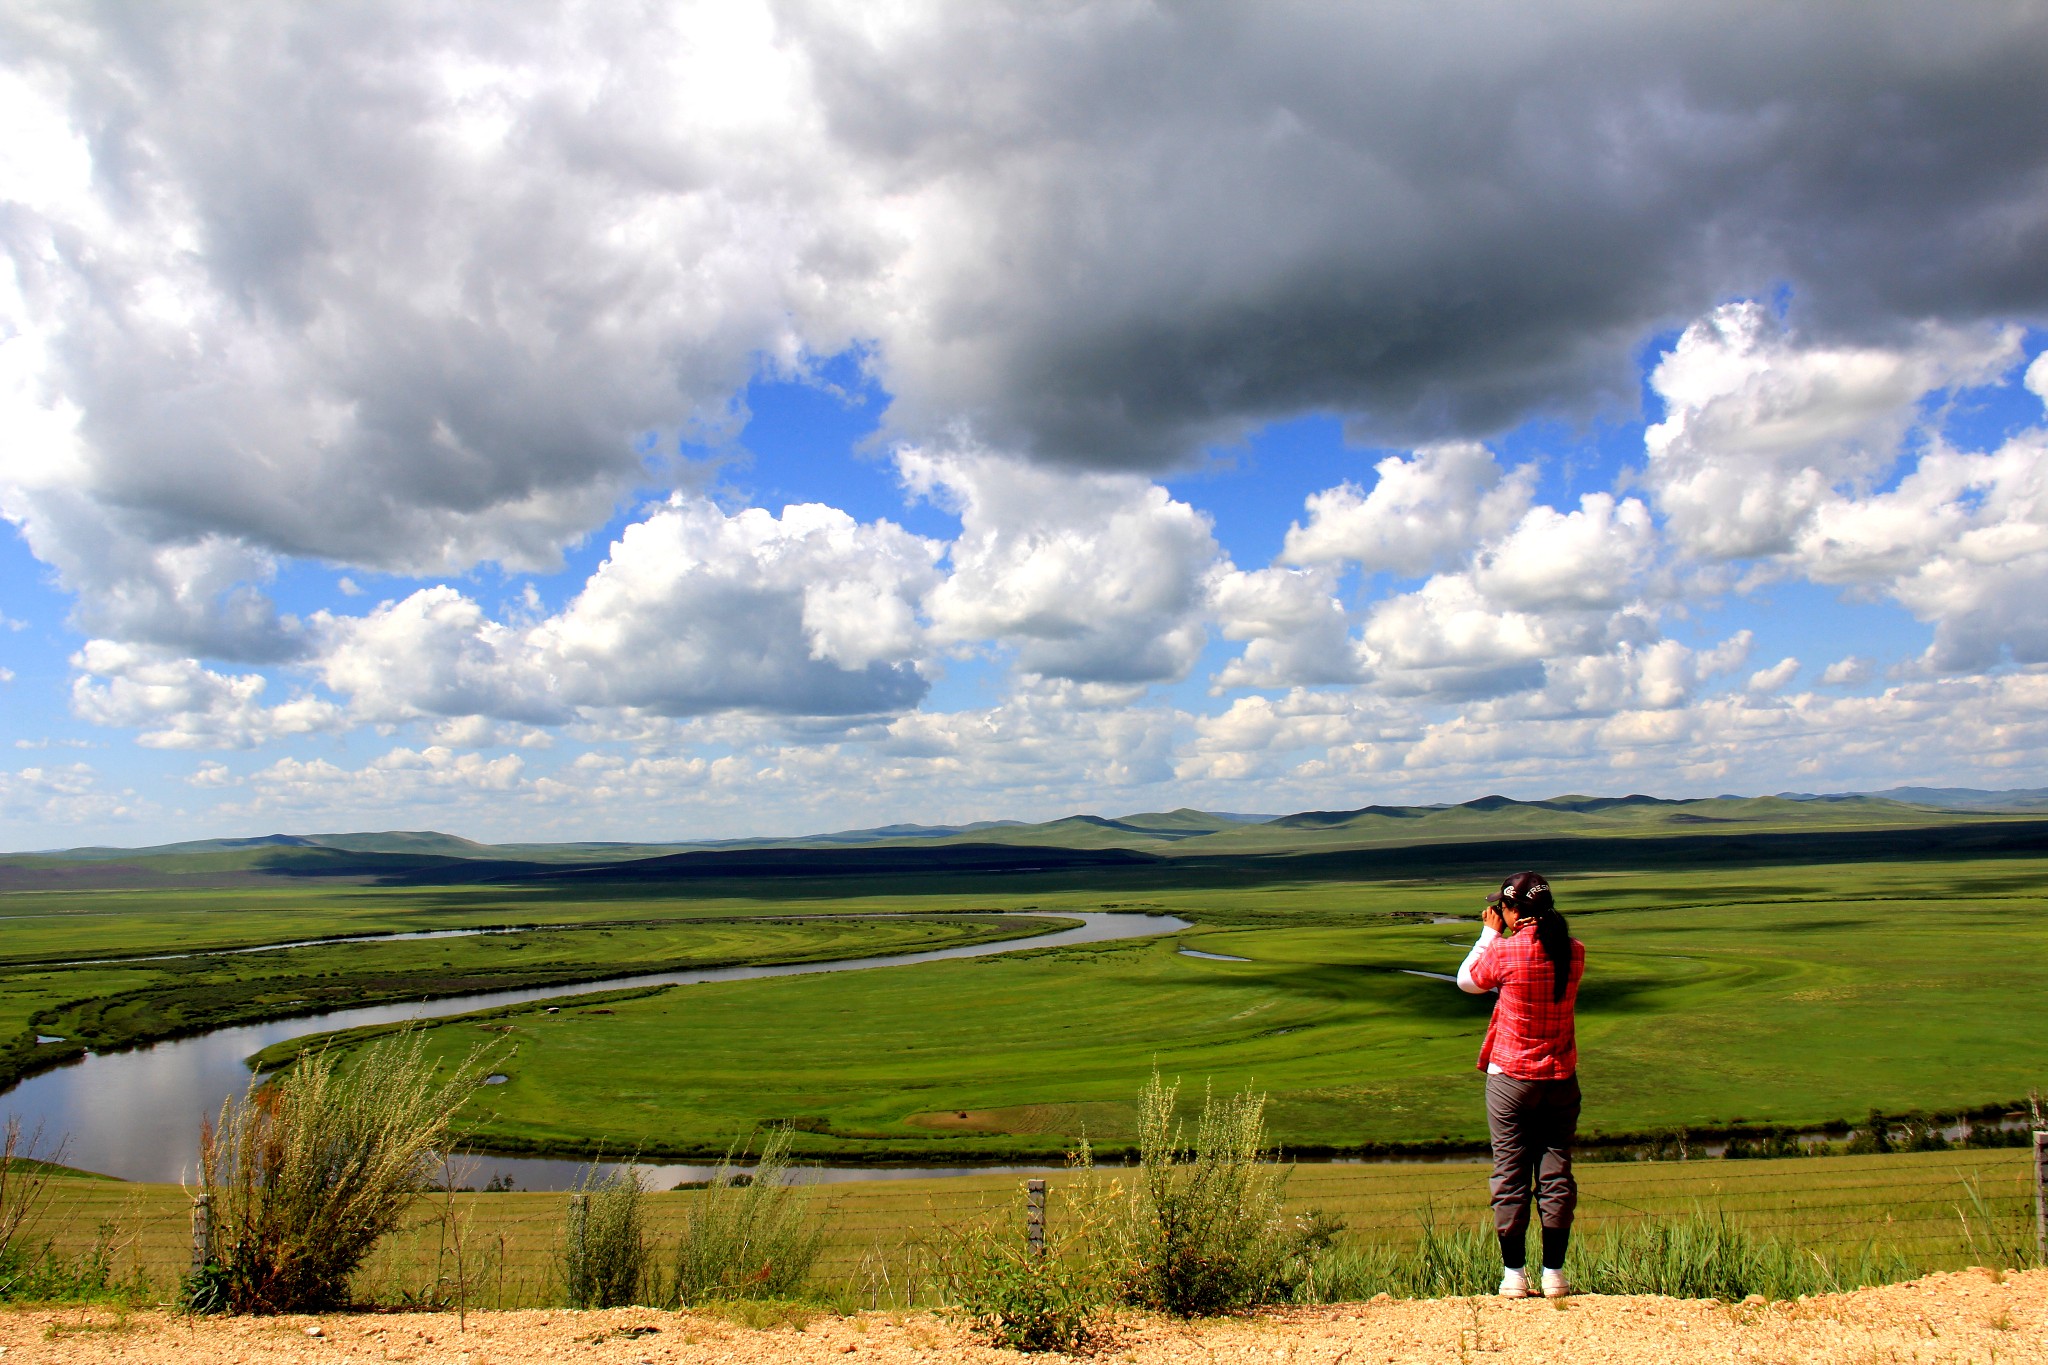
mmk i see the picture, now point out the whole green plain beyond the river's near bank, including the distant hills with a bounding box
[0,796,2048,1162]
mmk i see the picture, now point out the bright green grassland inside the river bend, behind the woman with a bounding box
[331,860,2048,1162]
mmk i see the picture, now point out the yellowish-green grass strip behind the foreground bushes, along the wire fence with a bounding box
[29,1150,2032,1308]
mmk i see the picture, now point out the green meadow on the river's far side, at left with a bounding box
[0,886,1049,1109]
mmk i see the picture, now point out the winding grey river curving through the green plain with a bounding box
[0,911,1192,1189]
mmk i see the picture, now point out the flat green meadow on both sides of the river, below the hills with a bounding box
[0,841,2048,1164]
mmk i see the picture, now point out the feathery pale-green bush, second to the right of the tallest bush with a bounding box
[670,1124,825,1304]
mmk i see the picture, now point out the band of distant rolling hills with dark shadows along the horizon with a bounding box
[0,792,2040,890]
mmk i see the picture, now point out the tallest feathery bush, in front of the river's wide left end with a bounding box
[193,1027,495,1314]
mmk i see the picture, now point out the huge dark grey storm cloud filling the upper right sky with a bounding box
[805,4,2048,465]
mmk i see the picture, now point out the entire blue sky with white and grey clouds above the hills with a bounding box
[0,0,2048,849]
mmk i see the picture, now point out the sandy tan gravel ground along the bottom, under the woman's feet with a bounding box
[0,1271,2048,1365]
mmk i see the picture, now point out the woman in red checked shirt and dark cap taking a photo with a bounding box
[1458,872,1585,1300]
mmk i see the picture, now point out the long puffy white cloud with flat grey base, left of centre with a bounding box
[315,493,940,724]
